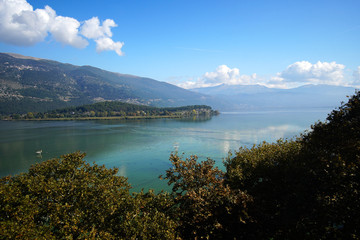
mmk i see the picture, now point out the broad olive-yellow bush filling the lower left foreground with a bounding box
[0,153,176,239]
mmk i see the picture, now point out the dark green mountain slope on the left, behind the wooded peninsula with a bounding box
[0,53,215,114]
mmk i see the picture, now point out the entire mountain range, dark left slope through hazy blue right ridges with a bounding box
[0,53,355,114]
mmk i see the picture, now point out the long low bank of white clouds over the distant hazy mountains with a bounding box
[178,61,354,89]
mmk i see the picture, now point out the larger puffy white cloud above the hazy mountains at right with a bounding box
[278,61,346,85]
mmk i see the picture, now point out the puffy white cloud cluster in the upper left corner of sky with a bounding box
[0,0,123,55]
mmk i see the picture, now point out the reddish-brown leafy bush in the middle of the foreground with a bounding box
[164,154,251,239]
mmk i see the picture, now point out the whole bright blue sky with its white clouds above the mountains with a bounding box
[0,0,360,88]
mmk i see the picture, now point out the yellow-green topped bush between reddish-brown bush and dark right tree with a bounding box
[225,140,311,239]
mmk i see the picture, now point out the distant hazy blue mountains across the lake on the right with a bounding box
[192,84,355,111]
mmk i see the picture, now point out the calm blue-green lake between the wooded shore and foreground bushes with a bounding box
[0,109,331,191]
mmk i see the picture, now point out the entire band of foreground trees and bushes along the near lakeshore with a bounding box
[0,92,360,239]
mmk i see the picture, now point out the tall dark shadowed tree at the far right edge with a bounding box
[303,92,360,239]
